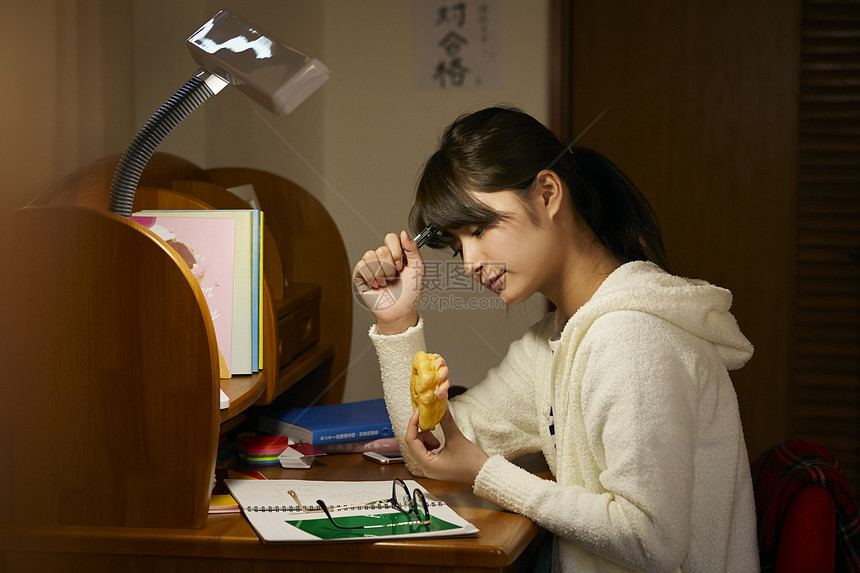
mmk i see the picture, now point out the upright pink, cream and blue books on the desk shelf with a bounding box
[131,209,263,377]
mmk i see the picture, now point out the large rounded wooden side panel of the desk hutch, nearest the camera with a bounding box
[0,205,219,528]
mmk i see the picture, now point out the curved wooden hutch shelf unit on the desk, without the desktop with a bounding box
[0,153,352,529]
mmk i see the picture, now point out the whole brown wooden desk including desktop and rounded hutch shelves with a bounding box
[0,154,536,573]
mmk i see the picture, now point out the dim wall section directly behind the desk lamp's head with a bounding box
[133,0,326,197]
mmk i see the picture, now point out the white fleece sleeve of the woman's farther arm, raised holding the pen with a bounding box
[370,318,546,475]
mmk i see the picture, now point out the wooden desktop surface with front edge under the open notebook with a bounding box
[0,454,538,573]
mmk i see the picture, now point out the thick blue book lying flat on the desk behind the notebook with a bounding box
[258,398,394,446]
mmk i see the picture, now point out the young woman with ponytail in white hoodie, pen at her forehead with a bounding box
[354,108,758,571]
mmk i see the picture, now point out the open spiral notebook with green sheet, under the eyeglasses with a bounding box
[224,479,478,543]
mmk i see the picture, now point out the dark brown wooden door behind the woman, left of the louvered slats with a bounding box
[551,0,800,464]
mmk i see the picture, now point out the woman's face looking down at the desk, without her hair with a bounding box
[451,191,552,304]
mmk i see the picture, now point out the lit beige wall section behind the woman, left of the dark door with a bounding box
[316,0,548,399]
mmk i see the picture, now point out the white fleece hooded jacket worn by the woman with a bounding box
[370,262,758,572]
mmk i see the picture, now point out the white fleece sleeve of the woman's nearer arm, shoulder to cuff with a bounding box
[475,313,702,571]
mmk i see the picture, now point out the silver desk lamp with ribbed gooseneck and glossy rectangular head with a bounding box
[109,10,328,217]
